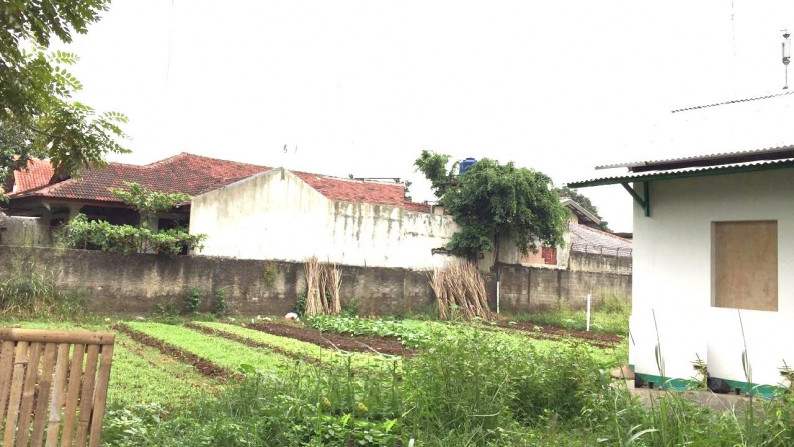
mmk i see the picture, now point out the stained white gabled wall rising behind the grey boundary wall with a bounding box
[190,169,457,269]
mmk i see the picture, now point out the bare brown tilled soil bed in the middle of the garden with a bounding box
[248,322,413,357]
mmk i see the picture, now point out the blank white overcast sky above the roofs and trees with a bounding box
[52,0,794,231]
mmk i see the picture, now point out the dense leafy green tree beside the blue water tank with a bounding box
[415,151,569,259]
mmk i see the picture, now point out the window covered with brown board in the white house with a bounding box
[712,220,778,311]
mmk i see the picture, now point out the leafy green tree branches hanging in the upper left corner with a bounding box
[0,0,127,196]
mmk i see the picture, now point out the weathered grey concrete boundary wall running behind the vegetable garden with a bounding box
[0,246,631,315]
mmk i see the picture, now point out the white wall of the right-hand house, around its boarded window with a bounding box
[629,169,794,385]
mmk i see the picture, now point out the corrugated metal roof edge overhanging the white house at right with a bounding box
[567,158,794,188]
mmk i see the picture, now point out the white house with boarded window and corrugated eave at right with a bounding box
[569,146,794,392]
